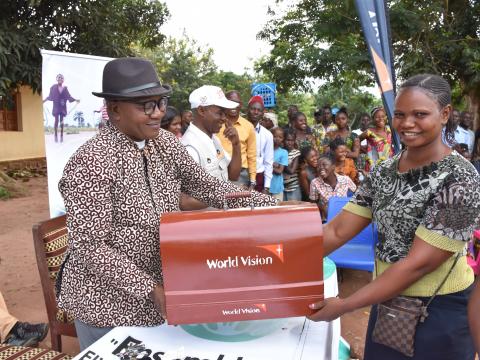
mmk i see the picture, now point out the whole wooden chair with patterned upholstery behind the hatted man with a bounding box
[32,215,77,352]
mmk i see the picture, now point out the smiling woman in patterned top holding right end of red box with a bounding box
[310,74,480,360]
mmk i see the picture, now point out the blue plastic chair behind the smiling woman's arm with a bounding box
[327,196,377,272]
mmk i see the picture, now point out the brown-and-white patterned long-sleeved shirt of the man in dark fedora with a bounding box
[57,123,276,327]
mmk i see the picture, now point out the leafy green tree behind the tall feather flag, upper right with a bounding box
[257,0,480,119]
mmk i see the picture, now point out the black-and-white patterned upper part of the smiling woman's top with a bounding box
[346,151,480,263]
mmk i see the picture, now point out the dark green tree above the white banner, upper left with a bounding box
[0,0,169,96]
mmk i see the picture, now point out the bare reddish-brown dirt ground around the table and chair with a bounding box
[0,177,371,358]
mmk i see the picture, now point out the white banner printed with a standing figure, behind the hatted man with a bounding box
[41,50,111,217]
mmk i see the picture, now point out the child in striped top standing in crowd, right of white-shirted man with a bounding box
[283,128,302,201]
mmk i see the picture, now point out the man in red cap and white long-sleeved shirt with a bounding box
[247,95,273,193]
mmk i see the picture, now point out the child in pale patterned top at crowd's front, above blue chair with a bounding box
[310,152,357,219]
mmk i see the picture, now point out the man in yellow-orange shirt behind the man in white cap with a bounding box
[217,90,257,189]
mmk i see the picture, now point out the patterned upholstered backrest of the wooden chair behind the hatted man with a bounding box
[32,215,68,322]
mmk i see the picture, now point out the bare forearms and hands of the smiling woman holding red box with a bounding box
[309,211,452,321]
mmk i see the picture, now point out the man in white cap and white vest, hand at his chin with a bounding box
[180,85,242,210]
